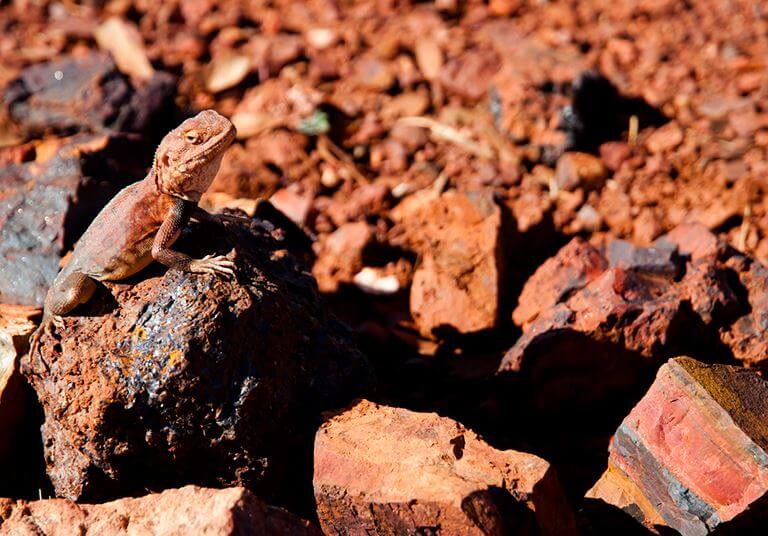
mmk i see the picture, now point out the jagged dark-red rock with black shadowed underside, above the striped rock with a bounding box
[499,246,736,411]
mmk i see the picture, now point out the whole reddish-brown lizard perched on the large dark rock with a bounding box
[29,110,240,357]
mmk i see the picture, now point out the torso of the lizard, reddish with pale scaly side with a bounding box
[56,178,173,282]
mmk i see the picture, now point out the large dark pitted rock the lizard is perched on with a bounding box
[23,214,371,500]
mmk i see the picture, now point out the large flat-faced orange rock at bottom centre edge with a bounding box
[314,400,575,535]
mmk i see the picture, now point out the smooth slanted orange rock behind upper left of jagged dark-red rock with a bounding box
[512,238,608,329]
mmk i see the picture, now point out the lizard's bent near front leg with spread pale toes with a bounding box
[152,200,235,277]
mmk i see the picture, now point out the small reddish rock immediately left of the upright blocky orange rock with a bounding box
[312,222,373,292]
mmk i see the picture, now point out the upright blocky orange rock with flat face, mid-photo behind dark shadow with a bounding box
[392,190,503,336]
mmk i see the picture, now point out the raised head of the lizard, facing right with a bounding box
[152,110,237,202]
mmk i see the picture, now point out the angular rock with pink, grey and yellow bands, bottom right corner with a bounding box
[587,357,768,536]
